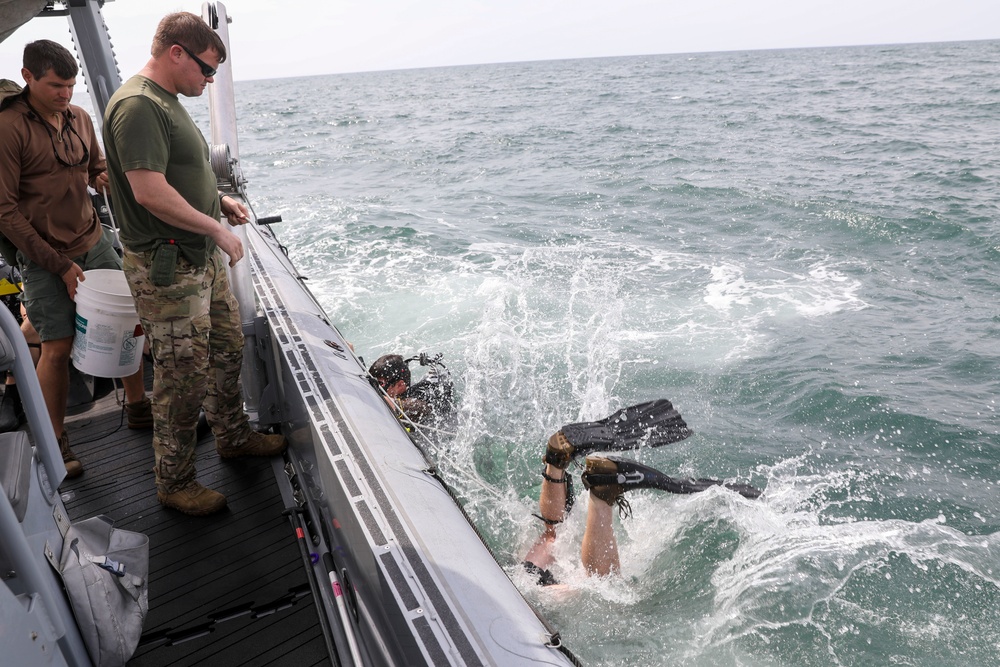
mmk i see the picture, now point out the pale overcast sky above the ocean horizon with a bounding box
[0,0,1000,83]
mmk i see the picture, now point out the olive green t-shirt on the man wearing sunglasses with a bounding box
[104,75,221,266]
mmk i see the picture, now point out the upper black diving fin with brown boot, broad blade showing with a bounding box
[544,398,694,469]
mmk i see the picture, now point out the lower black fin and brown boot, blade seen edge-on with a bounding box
[582,456,761,516]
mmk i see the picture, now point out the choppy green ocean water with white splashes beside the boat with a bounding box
[215,42,1000,667]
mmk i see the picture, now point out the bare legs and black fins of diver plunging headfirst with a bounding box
[524,399,761,586]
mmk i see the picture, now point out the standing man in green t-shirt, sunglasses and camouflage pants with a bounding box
[104,12,285,515]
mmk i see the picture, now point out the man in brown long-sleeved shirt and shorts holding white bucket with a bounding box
[0,40,152,477]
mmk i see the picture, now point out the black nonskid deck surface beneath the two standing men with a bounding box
[60,365,330,667]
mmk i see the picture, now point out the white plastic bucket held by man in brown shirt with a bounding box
[72,269,146,378]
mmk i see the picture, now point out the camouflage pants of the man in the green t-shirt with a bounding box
[124,250,251,493]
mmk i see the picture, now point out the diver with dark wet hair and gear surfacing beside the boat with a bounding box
[368,353,452,424]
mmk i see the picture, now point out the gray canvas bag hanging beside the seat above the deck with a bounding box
[45,516,149,667]
